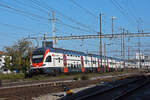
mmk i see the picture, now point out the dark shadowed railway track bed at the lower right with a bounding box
[62,76,150,100]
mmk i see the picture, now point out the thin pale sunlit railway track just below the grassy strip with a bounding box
[0,73,136,89]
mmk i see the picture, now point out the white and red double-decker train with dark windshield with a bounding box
[30,47,136,74]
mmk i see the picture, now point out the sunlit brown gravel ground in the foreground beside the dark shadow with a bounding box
[0,73,138,100]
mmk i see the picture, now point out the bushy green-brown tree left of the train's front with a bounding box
[4,40,32,72]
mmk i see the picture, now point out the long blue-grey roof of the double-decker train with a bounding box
[33,47,126,61]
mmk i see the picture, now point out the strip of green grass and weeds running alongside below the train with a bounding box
[0,70,140,83]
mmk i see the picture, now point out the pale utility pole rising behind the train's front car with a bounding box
[50,11,56,47]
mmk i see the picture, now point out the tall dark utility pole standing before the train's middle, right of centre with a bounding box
[99,13,102,66]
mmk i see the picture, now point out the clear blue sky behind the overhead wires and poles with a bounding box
[0,0,150,56]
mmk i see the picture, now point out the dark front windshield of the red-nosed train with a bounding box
[32,50,45,63]
